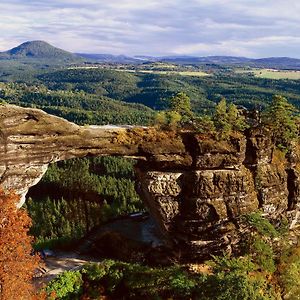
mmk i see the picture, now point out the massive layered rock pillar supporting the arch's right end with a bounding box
[138,129,300,259]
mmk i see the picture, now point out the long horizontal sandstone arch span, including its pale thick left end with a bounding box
[0,105,191,204]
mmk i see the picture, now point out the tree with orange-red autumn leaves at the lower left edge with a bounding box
[0,189,39,300]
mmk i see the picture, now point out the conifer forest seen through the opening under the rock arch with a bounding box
[26,157,144,248]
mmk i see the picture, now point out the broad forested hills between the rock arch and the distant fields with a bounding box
[0,68,300,119]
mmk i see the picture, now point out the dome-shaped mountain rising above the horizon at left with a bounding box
[0,41,82,63]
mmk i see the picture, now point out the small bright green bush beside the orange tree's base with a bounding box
[45,271,83,300]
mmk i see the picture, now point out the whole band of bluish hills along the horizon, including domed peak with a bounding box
[0,41,300,70]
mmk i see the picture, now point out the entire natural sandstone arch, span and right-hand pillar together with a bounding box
[0,105,300,257]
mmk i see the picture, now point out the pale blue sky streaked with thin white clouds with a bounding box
[0,0,300,58]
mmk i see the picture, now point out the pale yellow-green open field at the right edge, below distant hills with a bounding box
[235,69,300,80]
